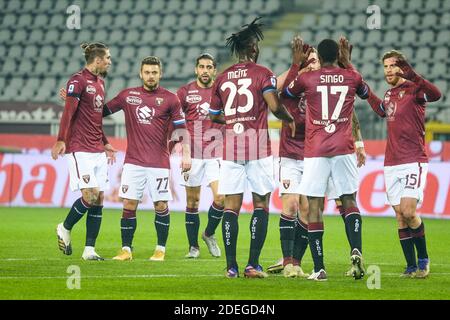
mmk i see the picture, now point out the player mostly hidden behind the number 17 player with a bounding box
[267,36,366,277]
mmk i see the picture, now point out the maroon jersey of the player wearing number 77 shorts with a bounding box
[106,87,185,168]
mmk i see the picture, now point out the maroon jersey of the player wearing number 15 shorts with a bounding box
[383,81,428,166]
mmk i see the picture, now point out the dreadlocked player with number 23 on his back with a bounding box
[210,18,295,278]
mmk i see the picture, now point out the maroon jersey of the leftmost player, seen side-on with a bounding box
[66,68,105,153]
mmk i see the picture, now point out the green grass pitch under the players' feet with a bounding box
[0,207,450,300]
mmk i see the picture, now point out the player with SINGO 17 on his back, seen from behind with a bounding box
[283,39,369,281]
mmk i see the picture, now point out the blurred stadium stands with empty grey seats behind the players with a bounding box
[0,0,450,215]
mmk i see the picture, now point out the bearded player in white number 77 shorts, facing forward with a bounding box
[61,57,191,261]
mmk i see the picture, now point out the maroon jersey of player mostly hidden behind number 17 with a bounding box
[279,95,306,160]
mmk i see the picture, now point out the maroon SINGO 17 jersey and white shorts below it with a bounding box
[284,66,369,197]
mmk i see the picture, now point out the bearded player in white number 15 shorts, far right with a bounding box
[368,50,441,278]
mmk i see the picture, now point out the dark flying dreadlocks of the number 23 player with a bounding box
[226,17,264,57]
